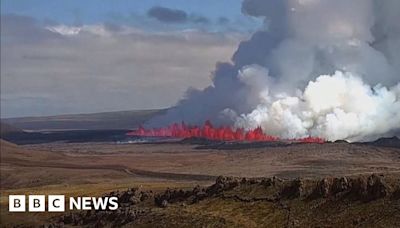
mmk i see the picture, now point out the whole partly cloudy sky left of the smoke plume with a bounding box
[1,0,262,118]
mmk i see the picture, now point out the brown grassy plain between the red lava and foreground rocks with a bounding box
[0,140,400,227]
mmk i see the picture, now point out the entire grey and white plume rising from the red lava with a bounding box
[151,0,400,141]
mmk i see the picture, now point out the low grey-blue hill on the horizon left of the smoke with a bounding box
[1,109,167,132]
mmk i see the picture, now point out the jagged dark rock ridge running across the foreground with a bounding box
[50,174,400,227]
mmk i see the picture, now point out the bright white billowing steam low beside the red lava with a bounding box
[231,66,400,141]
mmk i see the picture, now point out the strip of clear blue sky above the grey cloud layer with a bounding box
[1,0,261,31]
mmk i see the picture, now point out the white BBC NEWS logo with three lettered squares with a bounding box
[8,195,118,212]
